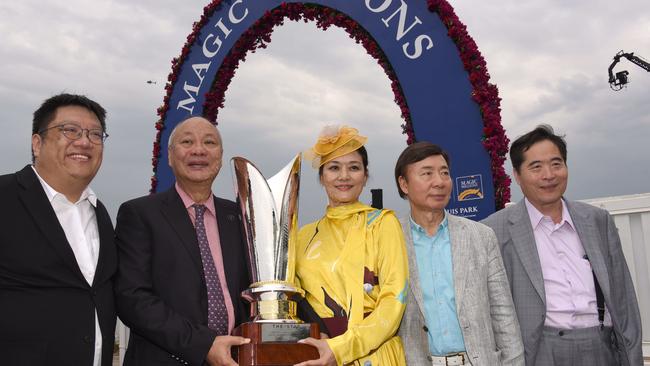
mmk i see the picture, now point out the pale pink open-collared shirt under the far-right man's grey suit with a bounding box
[525,199,611,329]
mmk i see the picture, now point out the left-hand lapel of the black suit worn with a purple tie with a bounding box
[161,187,203,276]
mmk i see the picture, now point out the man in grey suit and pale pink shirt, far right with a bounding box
[483,125,643,366]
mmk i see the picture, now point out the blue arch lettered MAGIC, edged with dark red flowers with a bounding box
[154,0,506,219]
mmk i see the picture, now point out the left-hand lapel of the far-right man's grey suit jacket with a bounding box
[508,199,546,304]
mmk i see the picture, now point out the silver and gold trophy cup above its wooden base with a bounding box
[231,155,304,328]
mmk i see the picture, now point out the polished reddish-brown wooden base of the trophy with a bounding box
[233,322,320,366]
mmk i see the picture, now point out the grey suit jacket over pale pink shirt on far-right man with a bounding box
[483,200,643,366]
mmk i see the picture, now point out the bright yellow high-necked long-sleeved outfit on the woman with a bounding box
[296,202,408,366]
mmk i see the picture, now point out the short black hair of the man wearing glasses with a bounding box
[32,93,106,135]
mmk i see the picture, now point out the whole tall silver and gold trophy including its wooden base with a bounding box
[231,155,320,366]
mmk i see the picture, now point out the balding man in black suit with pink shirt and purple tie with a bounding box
[116,117,249,365]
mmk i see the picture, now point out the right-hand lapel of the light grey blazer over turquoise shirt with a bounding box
[447,215,471,314]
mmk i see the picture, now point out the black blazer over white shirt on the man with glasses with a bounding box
[0,165,117,366]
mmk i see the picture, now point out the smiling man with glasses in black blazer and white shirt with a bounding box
[0,94,117,366]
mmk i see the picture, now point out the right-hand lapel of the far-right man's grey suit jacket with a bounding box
[565,201,610,299]
